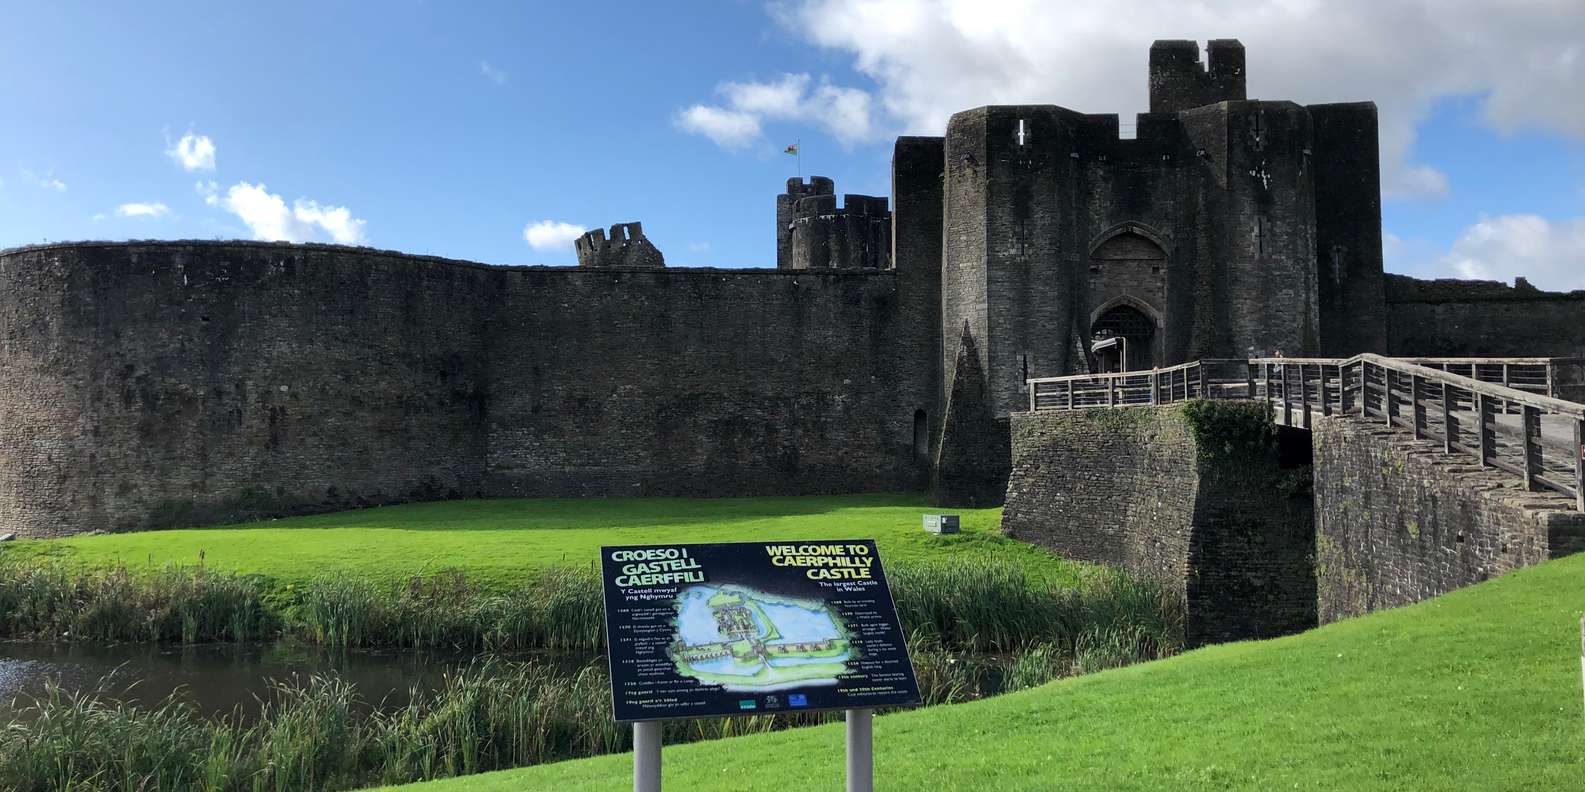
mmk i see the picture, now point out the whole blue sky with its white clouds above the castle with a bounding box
[0,0,1585,288]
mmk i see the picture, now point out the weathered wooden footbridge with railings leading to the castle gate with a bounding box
[1027,355,1585,512]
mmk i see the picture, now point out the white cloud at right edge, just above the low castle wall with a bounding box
[1442,214,1585,290]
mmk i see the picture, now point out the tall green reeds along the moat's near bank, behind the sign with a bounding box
[0,630,1166,792]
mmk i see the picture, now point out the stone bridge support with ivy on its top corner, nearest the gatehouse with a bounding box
[1002,402,1316,645]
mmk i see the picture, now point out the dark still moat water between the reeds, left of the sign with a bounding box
[0,642,594,722]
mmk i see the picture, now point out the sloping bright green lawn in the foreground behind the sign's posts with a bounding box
[370,554,1585,792]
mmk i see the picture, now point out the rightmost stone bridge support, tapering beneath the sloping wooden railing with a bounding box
[1314,417,1585,623]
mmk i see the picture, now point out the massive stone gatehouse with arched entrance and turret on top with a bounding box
[925,40,1385,417]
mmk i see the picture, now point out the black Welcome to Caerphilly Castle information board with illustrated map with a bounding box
[601,539,919,721]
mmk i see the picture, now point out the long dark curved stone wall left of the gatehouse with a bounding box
[0,242,935,535]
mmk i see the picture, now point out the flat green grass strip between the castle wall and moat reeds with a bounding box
[3,494,1087,586]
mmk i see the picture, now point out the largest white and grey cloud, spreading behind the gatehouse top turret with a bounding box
[760,0,1585,195]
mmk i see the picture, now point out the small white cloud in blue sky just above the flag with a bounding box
[677,74,878,149]
